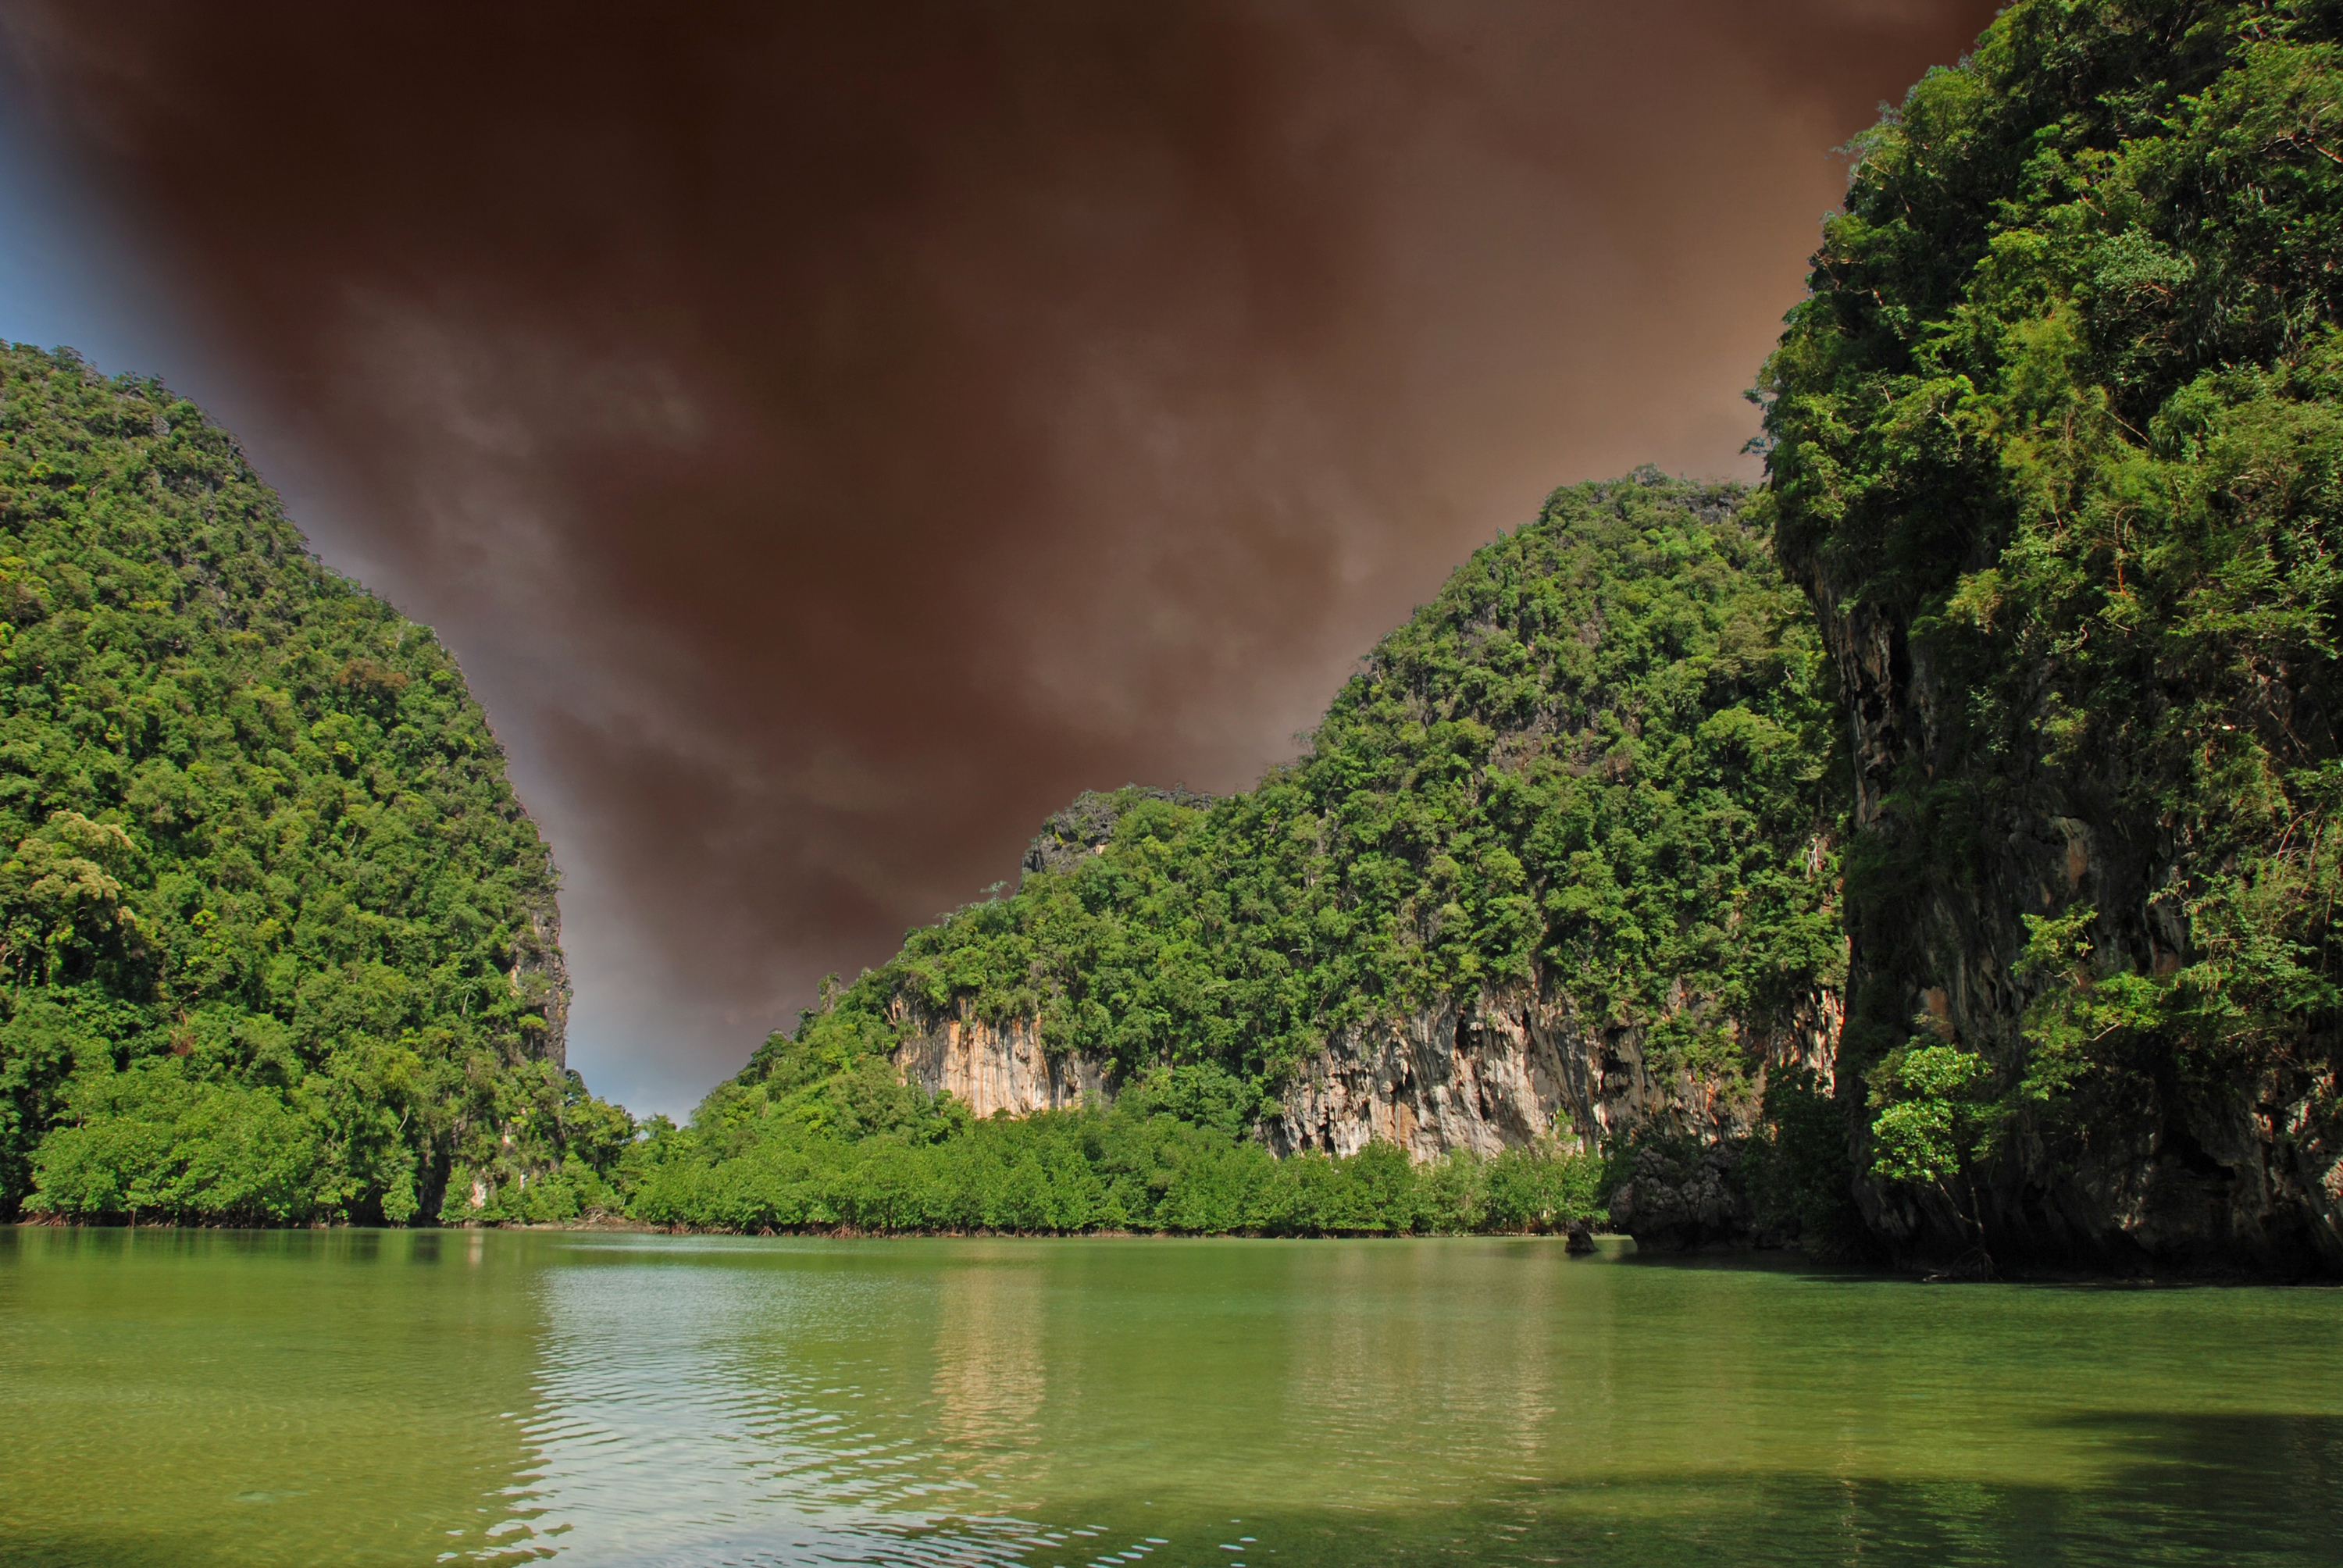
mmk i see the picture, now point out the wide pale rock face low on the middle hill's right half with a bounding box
[1265,989,1839,1160]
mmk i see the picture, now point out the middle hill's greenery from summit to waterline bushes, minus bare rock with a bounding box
[642,471,1844,1228]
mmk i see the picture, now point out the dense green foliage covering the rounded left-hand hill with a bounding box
[0,344,633,1221]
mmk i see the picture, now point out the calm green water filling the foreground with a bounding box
[0,1231,2343,1568]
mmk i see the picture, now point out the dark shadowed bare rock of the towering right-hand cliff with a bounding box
[1788,574,2343,1273]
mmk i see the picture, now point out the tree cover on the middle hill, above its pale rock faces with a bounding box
[872,471,1837,1097]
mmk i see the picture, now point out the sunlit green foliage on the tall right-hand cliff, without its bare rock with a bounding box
[1764,0,2343,1181]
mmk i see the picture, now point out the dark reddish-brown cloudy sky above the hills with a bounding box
[0,0,1994,1116]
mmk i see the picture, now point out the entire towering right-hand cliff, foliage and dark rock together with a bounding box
[1762,0,2343,1270]
